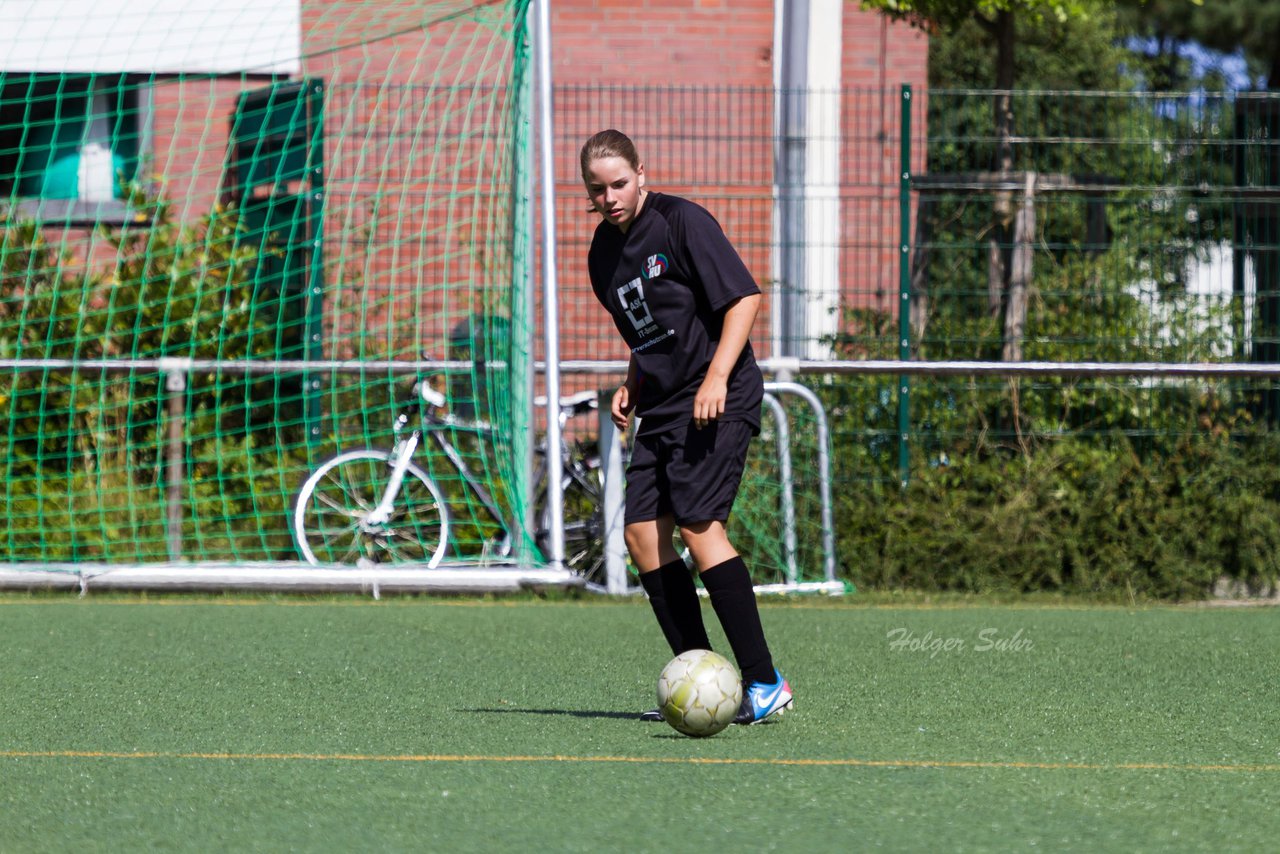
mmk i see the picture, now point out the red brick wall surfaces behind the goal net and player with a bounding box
[35,0,927,371]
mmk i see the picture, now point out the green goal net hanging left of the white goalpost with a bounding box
[0,0,536,562]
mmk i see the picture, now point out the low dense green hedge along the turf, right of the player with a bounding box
[836,431,1280,599]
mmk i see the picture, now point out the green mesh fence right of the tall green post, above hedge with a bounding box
[885,90,1280,481]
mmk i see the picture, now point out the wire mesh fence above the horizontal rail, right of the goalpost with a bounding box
[556,86,1280,361]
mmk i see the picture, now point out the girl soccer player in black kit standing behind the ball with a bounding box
[581,131,791,723]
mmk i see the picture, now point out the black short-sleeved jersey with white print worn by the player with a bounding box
[588,192,764,434]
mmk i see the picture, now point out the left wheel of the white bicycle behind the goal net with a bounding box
[293,449,449,567]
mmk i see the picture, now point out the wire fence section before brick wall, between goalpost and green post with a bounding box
[554,85,901,368]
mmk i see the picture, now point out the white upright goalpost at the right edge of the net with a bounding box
[534,0,564,568]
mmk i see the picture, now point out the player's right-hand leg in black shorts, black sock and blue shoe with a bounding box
[668,421,791,723]
